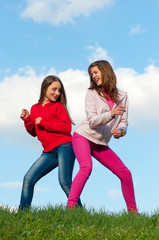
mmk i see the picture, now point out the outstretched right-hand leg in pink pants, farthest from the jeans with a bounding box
[92,144,137,213]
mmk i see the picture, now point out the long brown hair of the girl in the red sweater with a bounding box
[37,75,74,124]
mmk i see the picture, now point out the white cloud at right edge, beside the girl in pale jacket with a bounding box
[116,65,159,131]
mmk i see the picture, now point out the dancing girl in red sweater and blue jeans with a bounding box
[20,76,81,209]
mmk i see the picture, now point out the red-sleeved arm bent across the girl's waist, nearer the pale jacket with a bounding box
[38,104,71,133]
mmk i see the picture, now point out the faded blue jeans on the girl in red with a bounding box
[19,142,81,209]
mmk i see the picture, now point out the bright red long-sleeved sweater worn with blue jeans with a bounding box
[23,102,72,152]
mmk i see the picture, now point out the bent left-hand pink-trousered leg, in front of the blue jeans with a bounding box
[67,133,92,208]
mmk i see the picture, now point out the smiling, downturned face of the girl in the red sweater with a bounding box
[43,81,61,105]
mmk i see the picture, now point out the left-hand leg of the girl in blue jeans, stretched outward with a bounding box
[19,152,58,209]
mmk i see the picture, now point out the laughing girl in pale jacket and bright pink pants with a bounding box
[67,60,137,213]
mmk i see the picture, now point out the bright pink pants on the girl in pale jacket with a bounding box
[67,133,137,213]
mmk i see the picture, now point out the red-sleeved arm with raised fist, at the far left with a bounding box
[20,109,36,137]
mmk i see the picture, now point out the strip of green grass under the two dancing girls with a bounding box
[0,206,159,240]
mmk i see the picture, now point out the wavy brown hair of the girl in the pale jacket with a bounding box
[88,60,119,103]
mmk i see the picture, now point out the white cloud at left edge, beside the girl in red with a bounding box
[0,66,55,132]
